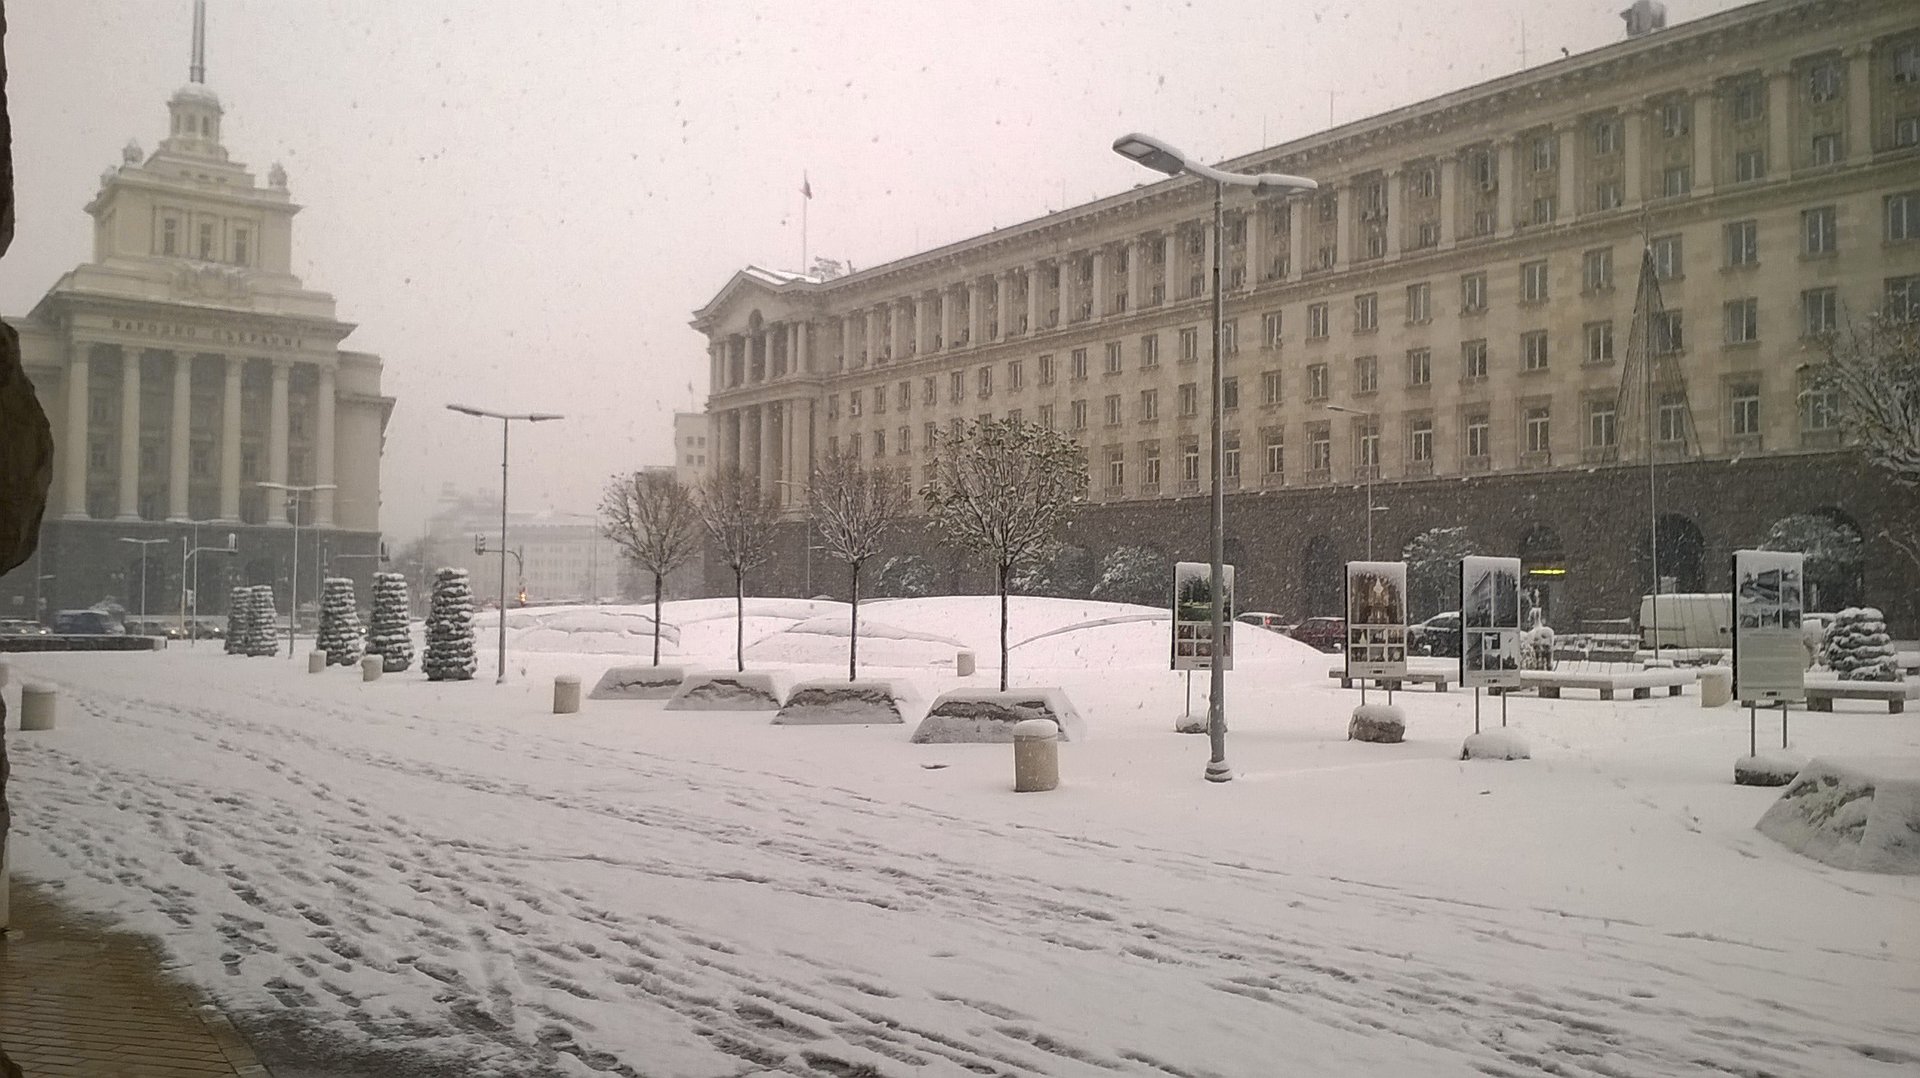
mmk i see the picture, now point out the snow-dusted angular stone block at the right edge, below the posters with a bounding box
[1757,757,1920,876]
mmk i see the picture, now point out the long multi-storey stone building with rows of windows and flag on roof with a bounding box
[693,0,1920,628]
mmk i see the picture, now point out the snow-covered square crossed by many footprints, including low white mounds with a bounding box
[6,598,1920,1076]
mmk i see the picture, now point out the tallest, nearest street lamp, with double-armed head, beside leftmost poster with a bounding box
[1114,133,1319,782]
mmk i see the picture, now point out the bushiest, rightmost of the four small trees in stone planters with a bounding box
[920,419,1087,692]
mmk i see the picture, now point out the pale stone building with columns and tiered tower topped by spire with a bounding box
[0,4,394,617]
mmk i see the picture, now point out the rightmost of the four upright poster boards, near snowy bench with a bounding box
[1734,550,1807,699]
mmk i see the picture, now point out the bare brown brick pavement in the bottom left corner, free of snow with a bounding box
[0,878,267,1078]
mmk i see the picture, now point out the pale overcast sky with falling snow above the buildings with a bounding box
[0,0,1736,538]
